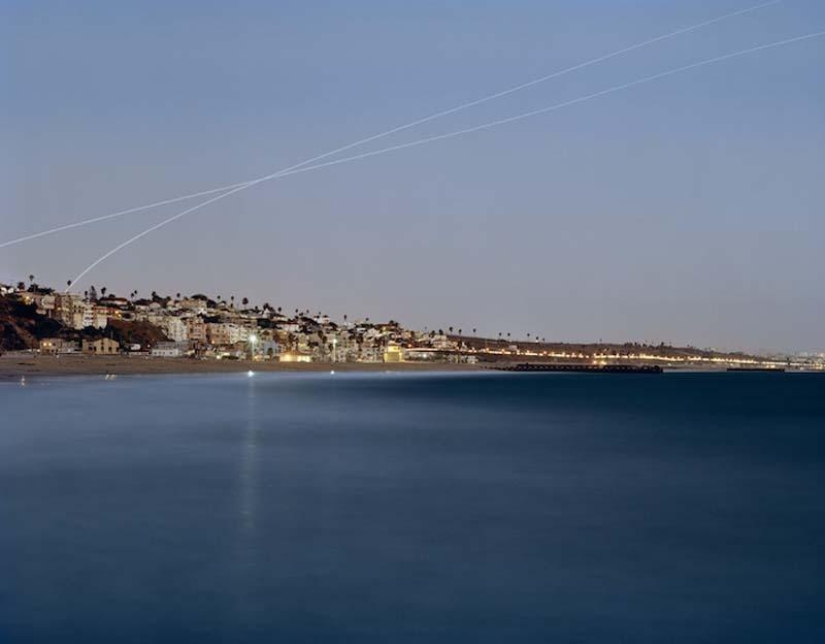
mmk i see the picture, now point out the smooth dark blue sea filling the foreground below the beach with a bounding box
[0,374,825,644]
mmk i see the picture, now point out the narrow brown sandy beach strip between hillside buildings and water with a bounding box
[0,354,482,378]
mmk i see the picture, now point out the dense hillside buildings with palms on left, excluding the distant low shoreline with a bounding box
[0,282,464,362]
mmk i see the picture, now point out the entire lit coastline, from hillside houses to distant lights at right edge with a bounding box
[0,276,825,370]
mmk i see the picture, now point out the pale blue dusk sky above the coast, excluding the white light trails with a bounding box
[0,0,825,351]
